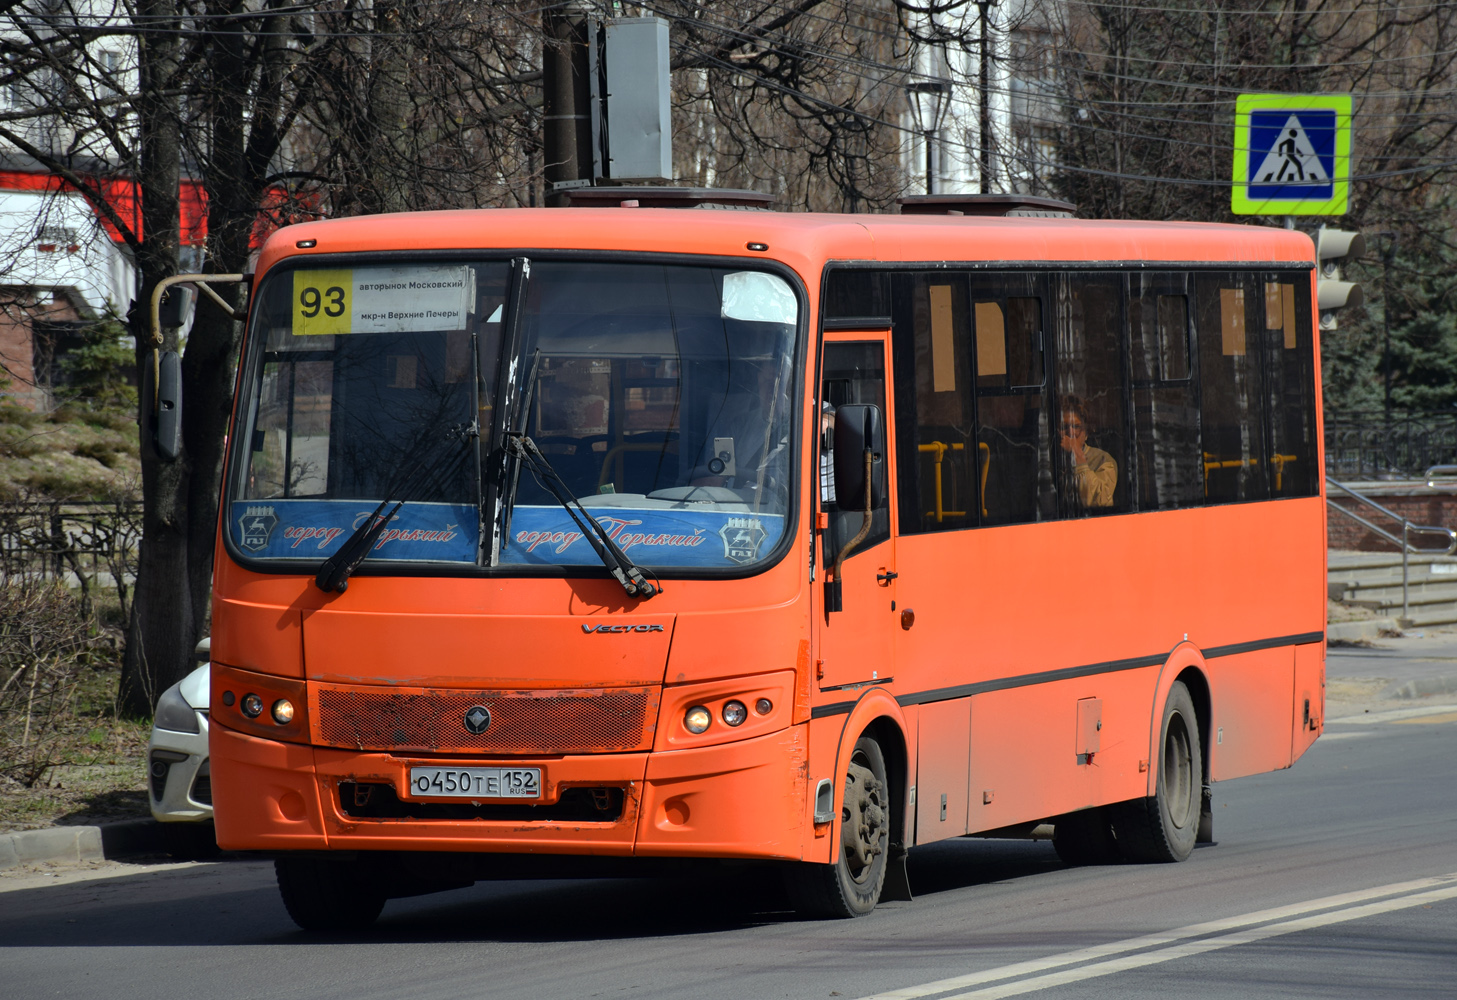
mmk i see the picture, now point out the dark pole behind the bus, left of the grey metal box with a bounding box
[542,3,592,207]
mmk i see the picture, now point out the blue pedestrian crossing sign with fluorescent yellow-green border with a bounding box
[1231,93,1351,216]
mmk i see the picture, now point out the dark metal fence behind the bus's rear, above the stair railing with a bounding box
[1326,410,1457,481]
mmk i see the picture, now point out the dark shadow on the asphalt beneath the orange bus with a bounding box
[0,840,1064,952]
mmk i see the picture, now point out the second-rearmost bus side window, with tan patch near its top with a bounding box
[1195,273,1271,503]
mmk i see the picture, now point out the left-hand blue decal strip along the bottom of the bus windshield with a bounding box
[229,500,479,563]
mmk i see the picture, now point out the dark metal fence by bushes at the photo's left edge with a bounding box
[0,501,141,611]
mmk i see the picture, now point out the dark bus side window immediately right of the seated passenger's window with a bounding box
[1128,274,1203,510]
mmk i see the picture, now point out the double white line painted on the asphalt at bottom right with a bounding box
[861,872,1457,1000]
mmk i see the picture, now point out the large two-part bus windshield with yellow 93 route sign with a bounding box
[227,259,800,571]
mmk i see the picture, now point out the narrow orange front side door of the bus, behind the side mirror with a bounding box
[817,331,899,691]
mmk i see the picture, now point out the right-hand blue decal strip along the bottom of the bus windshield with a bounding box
[501,506,784,567]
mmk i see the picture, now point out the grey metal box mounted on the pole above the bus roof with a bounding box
[606,17,673,181]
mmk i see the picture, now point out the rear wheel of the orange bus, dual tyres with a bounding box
[1113,681,1203,862]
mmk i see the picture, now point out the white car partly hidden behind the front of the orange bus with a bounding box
[147,638,217,857]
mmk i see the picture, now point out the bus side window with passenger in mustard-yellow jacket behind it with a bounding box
[1056,274,1131,516]
